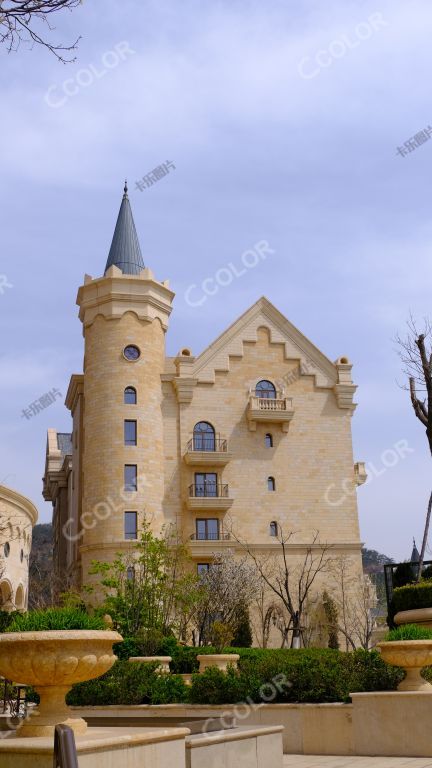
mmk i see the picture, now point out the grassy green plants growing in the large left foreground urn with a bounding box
[5,608,107,632]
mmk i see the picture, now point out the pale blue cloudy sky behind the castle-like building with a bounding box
[0,0,432,558]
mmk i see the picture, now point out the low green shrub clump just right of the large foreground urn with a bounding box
[66,661,188,707]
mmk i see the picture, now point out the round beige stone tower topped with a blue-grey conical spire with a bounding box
[74,185,174,581]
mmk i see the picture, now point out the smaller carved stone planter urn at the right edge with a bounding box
[377,640,432,693]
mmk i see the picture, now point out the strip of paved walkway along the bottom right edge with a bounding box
[284,755,432,768]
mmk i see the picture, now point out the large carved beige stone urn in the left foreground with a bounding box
[0,630,123,737]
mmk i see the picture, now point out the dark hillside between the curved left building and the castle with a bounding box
[29,523,53,608]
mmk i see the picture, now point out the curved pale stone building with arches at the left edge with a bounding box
[0,485,38,611]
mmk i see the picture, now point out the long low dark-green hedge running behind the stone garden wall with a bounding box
[67,648,404,706]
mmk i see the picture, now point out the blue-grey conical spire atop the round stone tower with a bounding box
[105,181,144,275]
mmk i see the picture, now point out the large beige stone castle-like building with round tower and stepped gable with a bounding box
[44,182,365,612]
